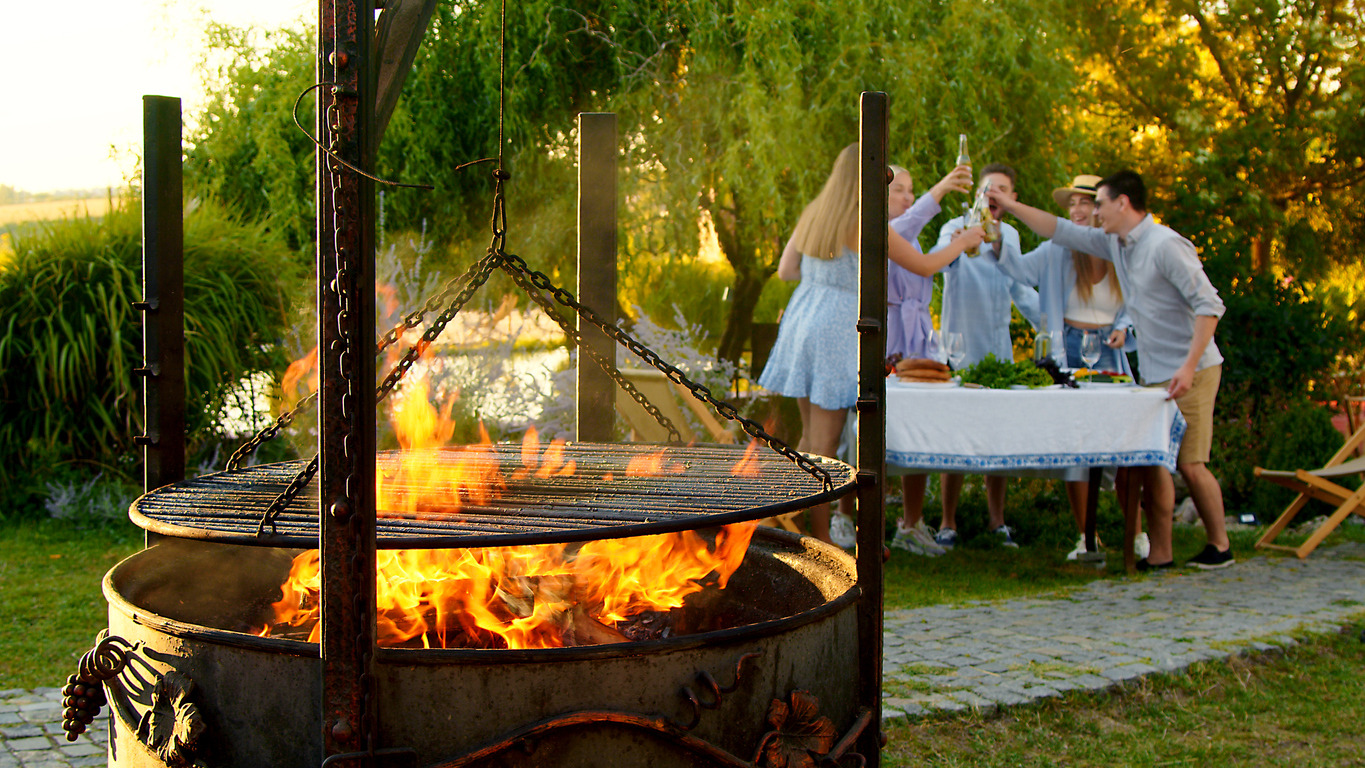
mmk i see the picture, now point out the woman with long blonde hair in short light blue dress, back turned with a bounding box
[759,143,983,542]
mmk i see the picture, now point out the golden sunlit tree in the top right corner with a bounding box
[1070,0,1365,278]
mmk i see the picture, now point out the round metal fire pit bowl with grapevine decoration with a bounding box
[102,527,865,768]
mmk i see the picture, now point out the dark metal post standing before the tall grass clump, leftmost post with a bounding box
[134,95,184,501]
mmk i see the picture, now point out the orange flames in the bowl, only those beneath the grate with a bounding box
[259,524,753,648]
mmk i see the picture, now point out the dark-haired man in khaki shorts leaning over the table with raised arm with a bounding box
[992,171,1234,570]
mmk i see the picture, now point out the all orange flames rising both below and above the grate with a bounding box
[261,342,758,648]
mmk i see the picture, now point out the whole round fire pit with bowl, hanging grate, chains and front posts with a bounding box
[64,0,887,768]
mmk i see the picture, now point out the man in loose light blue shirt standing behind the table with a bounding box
[934,162,1040,548]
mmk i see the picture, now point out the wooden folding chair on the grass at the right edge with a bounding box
[1254,426,1365,559]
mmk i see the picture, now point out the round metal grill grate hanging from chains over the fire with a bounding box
[130,443,854,548]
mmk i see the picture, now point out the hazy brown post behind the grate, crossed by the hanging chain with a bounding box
[577,112,617,442]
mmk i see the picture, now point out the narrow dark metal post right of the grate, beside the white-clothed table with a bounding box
[857,93,891,767]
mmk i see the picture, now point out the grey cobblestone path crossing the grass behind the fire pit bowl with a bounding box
[10,543,1365,768]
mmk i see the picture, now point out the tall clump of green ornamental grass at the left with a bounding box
[0,195,292,512]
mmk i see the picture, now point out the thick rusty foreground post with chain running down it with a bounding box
[317,0,378,765]
